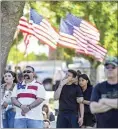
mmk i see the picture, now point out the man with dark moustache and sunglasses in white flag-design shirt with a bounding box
[12,66,45,128]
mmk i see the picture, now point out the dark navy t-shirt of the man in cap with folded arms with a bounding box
[91,81,118,128]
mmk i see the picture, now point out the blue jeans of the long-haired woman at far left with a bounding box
[3,109,16,128]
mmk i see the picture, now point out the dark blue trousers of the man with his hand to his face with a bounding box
[56,112,79,128]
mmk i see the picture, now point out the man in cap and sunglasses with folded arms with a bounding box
[90,57,118,128]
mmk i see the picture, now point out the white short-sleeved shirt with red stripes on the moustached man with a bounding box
[12,80,45,120]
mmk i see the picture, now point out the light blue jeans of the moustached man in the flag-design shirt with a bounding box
[14,118,44,128]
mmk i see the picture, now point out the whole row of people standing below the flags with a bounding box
[1,57,118,128]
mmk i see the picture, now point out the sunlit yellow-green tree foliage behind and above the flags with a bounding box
[9,1,118,62]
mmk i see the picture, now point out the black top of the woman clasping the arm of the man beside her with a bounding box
[83,86,93,113]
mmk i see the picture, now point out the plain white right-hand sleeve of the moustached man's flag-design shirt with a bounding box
[36,84,46,99]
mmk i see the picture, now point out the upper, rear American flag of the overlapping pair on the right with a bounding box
[66,14,100,44]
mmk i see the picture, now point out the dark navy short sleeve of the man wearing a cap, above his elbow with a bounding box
[91,84,101,102]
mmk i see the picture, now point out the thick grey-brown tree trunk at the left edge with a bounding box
[0,1,25,76]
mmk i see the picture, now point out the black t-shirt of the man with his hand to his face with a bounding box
[59,84,83,113]
